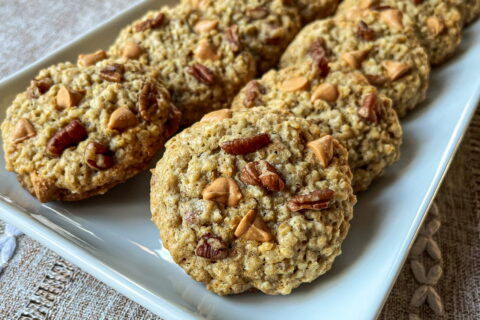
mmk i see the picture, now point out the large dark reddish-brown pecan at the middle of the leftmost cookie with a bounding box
[47,120,88,156]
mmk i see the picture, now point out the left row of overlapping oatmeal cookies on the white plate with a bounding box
[2,0,338,202]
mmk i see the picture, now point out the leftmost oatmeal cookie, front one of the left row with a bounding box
[1,57,180,202]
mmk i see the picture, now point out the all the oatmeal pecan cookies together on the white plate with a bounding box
[2,0,480,295]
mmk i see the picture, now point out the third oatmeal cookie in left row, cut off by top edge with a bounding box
[184,0,302,73]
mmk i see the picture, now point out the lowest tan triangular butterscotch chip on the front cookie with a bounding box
[234,210,273,242]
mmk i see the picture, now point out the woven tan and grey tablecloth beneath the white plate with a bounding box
[0,0,480,320]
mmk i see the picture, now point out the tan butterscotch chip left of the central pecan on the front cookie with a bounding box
[202,177,242,207]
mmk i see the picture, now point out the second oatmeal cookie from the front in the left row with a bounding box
[109,5,256,126]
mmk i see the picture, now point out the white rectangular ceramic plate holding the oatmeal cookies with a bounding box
[0,0,480,320]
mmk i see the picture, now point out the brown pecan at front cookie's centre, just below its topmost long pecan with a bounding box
[240,160,285,191]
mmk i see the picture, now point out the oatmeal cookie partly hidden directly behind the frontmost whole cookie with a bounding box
[232,64,402,192]
